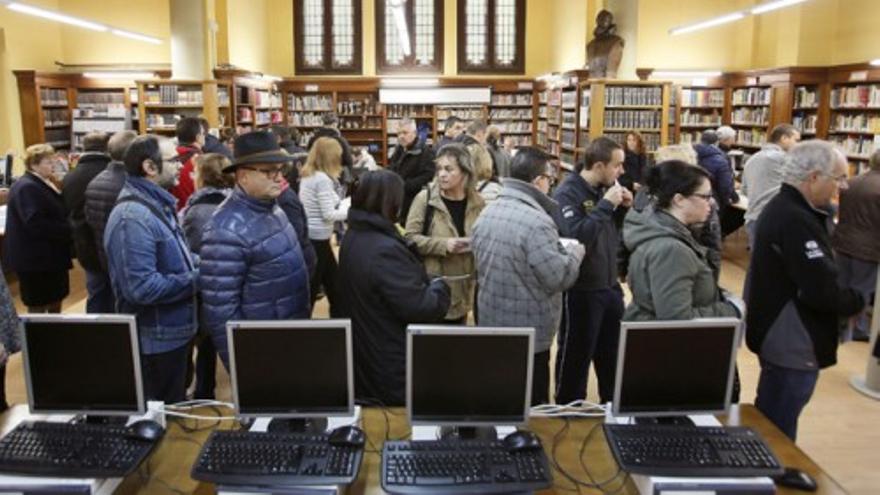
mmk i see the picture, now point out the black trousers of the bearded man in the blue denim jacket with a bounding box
[141,345,189,404]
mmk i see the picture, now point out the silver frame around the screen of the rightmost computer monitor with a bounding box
[611,318,743,417]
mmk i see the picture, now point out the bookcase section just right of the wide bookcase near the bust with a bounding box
[673,86,725,144]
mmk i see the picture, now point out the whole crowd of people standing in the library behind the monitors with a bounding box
[0,113,880,439]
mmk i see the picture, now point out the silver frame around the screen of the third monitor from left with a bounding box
[406,325,535,427]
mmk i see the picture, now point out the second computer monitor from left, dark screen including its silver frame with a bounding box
[227,320,354,418]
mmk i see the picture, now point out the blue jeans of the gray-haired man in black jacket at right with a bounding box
[755,360,819,442]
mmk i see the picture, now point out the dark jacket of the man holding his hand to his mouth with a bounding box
[553,172,620,290]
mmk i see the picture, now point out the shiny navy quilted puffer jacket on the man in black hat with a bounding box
[199,188,310,369]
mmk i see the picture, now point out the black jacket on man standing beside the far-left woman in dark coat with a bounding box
[61,153,110,272]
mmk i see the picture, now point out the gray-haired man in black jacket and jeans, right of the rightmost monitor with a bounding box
[746,140,865,441]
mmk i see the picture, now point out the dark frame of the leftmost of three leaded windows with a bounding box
[293,0,364,76]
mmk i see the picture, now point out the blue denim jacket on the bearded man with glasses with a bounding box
[104,176,198,354]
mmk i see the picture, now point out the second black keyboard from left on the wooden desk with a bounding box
[191,431,364,486]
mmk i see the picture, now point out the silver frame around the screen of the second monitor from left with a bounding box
[226,319,354,419]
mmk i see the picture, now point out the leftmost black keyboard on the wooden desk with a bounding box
[0,421,158,478]
